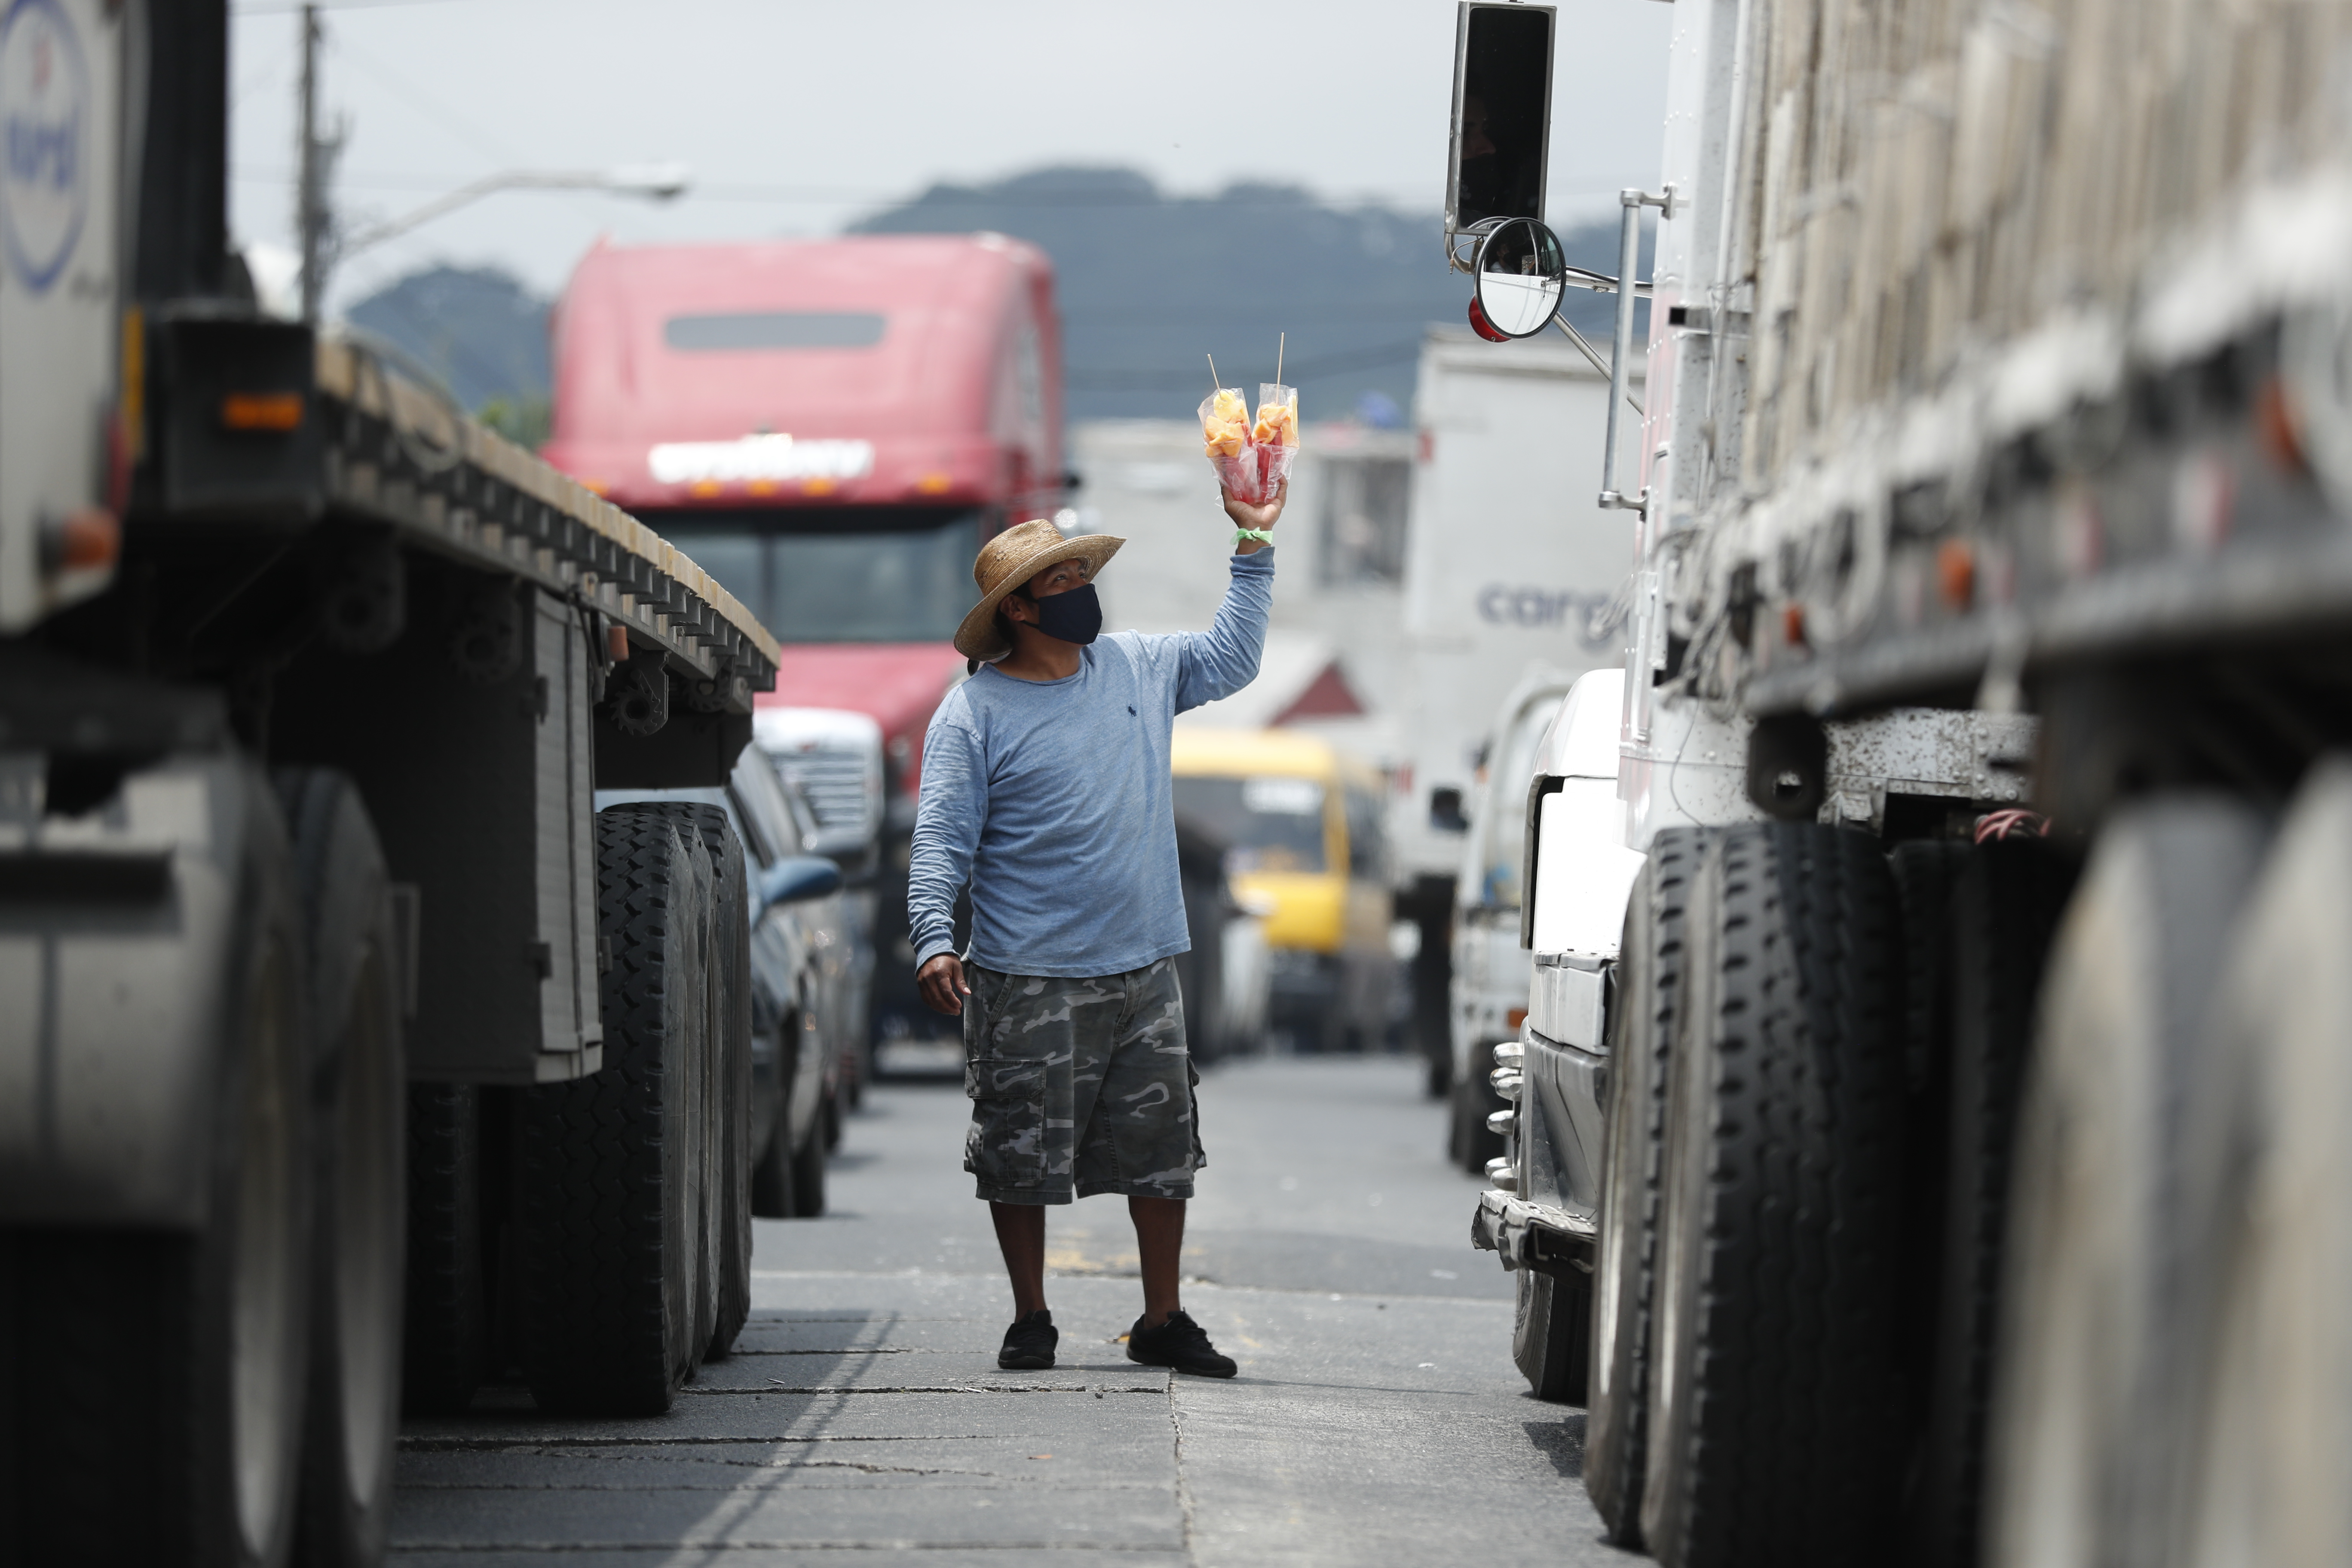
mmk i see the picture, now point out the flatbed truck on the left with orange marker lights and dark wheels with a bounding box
[0,0,790,1563]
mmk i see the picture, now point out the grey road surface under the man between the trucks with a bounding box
[393,1058,1637,1568]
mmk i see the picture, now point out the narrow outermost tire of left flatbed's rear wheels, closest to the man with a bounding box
[614,802,753,1359]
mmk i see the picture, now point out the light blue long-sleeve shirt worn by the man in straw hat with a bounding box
[906,550,1275,976]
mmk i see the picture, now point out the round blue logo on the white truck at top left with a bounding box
[0,0,89,294]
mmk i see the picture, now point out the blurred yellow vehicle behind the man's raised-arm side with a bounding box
[1171,726,1397,1051]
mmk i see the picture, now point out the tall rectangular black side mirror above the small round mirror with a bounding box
[1446,5,1553,270]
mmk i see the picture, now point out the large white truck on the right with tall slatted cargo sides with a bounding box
[1449,0,2352,1568]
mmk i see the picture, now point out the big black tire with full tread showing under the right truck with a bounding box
[1642,823,1903,1568]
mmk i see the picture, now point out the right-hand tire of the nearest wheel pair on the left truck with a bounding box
[275,769,407,1568]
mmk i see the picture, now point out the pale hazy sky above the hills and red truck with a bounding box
[230,0,1672,301]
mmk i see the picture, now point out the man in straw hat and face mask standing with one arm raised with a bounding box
[908,487,1286,1378]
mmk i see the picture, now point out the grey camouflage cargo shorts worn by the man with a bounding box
[965,959,1207,1204]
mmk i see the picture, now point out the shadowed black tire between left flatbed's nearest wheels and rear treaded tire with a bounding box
[400,1084,489,1415]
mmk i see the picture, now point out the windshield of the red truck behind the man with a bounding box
[644,508,981,642]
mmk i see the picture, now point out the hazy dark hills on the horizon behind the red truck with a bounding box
[350,167,1646,430]
